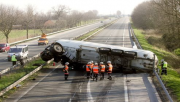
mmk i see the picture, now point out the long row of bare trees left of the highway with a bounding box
[0,4,98,43]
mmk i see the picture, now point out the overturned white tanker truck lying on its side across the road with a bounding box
[41,39,158,71]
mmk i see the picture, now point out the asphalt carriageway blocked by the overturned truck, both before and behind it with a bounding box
[5,17,160,102]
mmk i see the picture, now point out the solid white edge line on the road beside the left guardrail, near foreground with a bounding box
[14,65,60,102]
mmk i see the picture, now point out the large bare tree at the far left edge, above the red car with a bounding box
[0,5,20,43]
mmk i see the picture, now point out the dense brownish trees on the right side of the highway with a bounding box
[132,0,180,51]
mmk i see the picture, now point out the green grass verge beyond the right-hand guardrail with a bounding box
[133,27,180,101]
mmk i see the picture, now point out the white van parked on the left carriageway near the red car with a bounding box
[7,45,29,61]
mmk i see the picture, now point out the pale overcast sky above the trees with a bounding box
[0,0,148,14]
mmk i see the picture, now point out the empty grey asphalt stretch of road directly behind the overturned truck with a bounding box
[88,17,132,48]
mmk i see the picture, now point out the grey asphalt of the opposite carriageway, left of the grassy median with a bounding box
[0,18,115,71]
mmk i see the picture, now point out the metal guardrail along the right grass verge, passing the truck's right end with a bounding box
[130,23,173,102]
